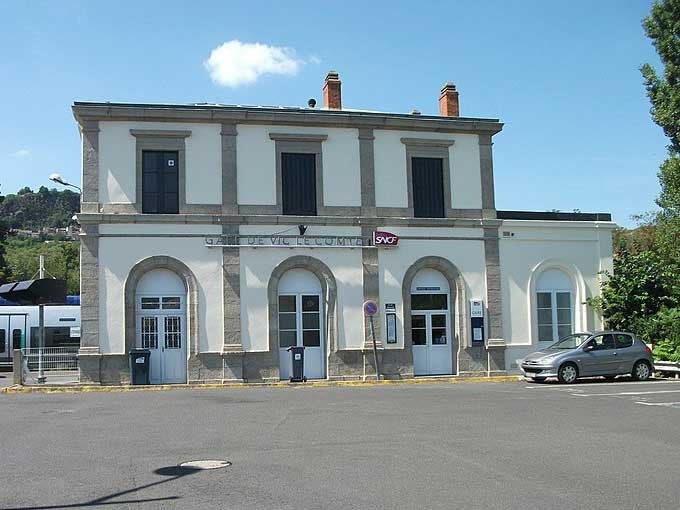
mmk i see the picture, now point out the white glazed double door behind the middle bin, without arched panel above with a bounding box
[279,293,326,380]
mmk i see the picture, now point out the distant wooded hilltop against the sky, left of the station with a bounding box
[0,186,80,230]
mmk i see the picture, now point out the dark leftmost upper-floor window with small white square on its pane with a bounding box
[142,151,179,214]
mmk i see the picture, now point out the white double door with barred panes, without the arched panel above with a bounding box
[137,296,187,384]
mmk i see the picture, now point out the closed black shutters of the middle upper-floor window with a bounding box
[281,152,316,216]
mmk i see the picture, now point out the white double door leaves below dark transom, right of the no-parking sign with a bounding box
[411,310,453,375]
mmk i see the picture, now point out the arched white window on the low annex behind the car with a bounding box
[536,269,574,342]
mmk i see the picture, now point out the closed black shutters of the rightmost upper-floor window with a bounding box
[411,158,444,218]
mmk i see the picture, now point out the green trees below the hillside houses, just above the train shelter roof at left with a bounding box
[5,238,80,295]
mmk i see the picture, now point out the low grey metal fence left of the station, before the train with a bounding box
[21,347,79,385]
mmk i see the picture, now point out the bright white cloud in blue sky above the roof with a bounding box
[203,39,305,87]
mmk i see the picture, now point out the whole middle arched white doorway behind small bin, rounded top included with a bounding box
[277,268,326,380]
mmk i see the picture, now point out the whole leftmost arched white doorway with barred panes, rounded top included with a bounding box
[135,269,188,384]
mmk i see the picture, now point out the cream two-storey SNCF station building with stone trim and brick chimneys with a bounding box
[73,72,615,384]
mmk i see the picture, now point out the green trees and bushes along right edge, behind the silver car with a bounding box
[608,0,680,361]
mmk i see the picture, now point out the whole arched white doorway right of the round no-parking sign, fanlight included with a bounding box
[411,268,453,375]
